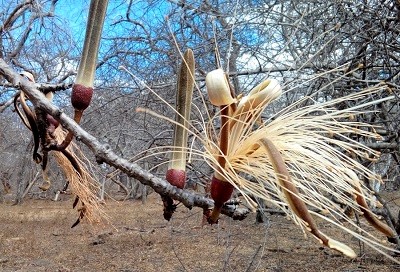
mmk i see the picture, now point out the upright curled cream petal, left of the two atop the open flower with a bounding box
[206,69,235,106]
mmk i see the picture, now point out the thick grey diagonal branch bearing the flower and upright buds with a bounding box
[0,59,249,220]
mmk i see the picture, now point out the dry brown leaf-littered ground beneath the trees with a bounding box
[0,193,400,272]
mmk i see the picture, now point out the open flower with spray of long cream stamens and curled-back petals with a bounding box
[201,70,396,258]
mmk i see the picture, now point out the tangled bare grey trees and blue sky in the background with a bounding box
[0,0,400,219]
